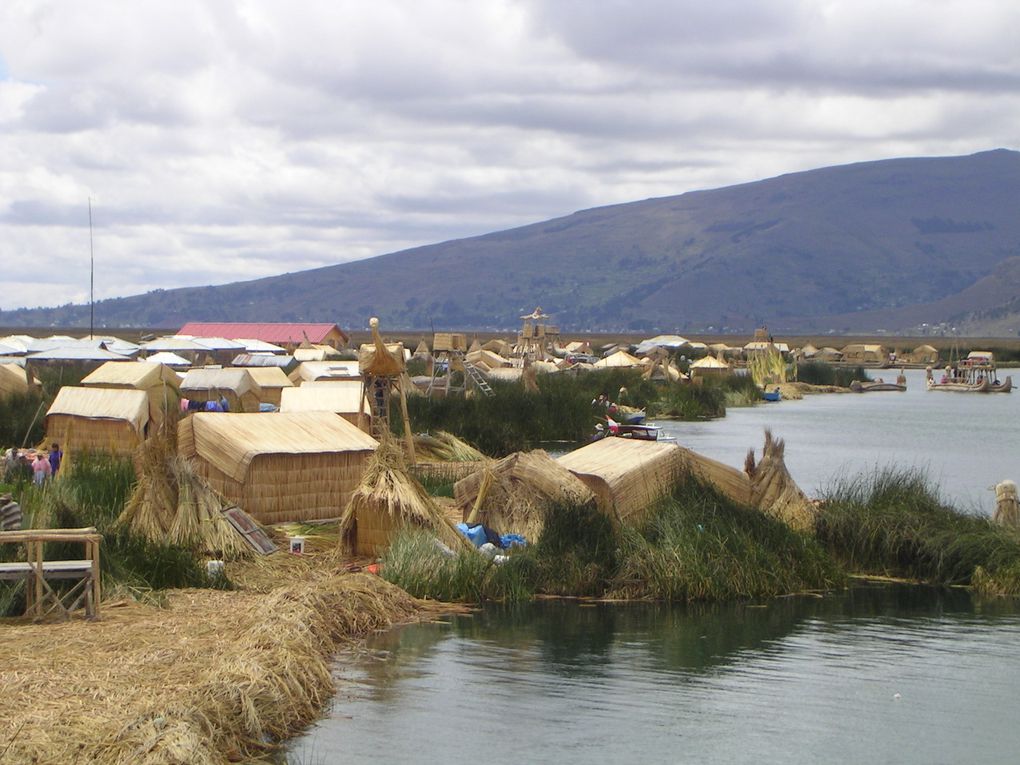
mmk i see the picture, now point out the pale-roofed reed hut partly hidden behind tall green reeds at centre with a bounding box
[559,438,751,524]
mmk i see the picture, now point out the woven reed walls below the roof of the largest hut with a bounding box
[194,452,371,524]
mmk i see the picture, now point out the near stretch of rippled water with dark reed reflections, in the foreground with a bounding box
[292,585,1020,763]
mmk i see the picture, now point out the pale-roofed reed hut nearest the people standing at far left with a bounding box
[46,385,149,463]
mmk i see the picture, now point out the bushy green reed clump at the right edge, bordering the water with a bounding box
[817,467,1020,594]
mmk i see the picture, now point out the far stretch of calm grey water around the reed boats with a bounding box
[659,369,1020,514]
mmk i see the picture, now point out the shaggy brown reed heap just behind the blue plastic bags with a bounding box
[454,449,595,542]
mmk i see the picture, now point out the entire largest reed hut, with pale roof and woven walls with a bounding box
[177,412,378,523]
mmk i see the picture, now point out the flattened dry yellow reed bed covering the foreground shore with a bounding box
[0,570,426,765]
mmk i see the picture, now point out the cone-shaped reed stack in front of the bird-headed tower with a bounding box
[339,440,470,556]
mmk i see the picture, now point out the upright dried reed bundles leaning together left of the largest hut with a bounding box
[117,420,252,559]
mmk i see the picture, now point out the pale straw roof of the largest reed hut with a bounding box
[181,414,378,482]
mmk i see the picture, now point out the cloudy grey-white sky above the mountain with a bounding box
[0,0,1020,309]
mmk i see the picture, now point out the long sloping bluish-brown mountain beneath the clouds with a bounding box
[0,149,1020,334]
